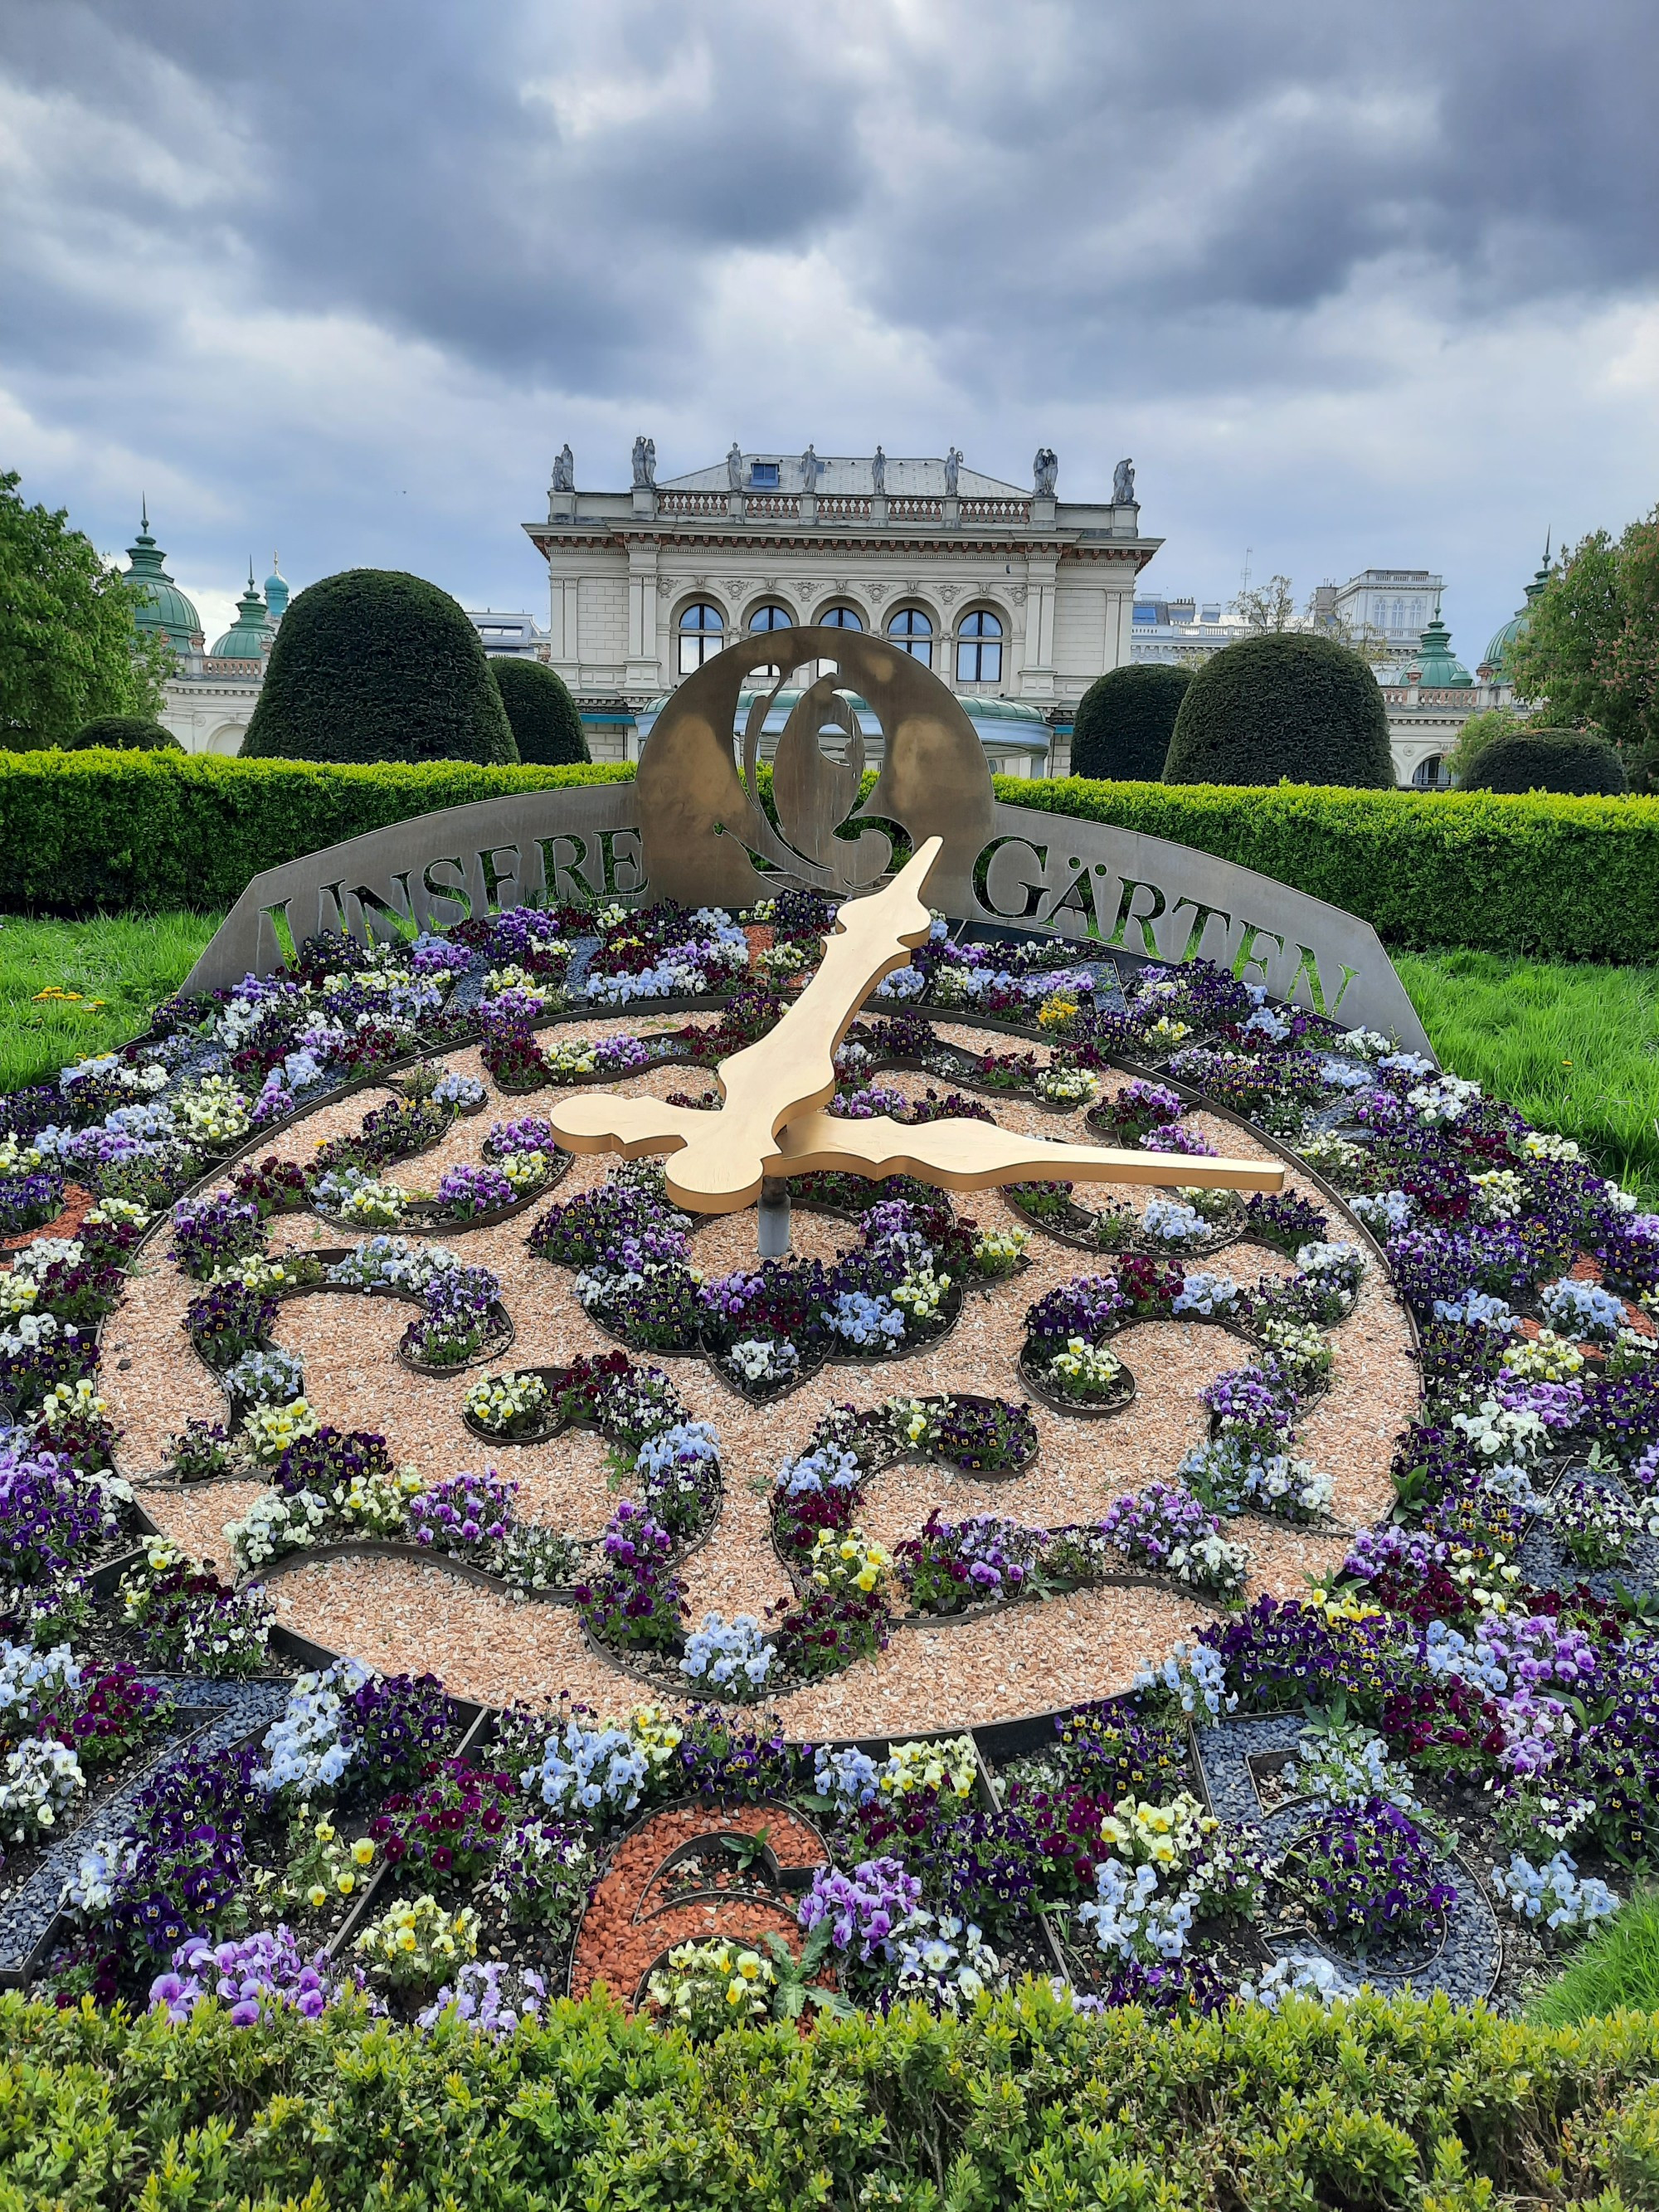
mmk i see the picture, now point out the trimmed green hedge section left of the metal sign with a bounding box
[0,752,633,914]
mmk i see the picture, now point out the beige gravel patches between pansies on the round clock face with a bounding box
[106,1017,1416,1734]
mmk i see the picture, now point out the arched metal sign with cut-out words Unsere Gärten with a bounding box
[186,628,1433,1057]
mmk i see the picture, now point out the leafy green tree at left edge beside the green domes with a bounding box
[0,471,173,752]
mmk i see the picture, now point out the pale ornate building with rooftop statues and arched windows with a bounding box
[526,441,1159,774]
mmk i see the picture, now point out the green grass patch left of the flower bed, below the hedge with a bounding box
[0,914,223,1090]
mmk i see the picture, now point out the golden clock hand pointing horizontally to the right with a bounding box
[766,1113,1285,1190]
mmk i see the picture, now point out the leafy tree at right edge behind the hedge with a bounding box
[1511,507,1659,792]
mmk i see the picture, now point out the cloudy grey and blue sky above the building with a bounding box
[0,0,1659,664]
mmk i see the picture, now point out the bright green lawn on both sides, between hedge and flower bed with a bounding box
[0,914,1659,1203]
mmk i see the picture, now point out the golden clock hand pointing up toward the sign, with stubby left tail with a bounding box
[548,836,945,1215]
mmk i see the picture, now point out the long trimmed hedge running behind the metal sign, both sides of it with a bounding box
[0,752,1659,960]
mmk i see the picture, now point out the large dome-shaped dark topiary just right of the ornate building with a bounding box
[1164,631,1394,792]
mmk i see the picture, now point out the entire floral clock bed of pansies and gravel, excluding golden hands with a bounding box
[0,907,1659,2035]
